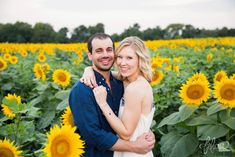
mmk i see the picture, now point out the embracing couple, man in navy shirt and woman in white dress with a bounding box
[69,33,155,157]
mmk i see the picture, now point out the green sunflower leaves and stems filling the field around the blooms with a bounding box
[0,41,235,157]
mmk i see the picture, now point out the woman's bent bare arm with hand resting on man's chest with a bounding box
[93,86,142,140]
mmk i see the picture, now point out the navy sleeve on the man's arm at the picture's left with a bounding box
[69,82,118,150]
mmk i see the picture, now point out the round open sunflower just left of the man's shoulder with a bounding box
[52,69,71,87]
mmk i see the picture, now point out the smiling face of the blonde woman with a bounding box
[117,46,139,77]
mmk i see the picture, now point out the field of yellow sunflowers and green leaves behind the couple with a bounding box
[0,37,235,157]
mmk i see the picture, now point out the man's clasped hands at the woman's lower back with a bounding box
[133,132,155,154]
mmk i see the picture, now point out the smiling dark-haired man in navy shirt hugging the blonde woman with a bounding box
[69,33,155,157]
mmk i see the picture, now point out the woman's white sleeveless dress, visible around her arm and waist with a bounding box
[113,98,155,157]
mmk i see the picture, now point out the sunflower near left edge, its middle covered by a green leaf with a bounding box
[1,94,21,118]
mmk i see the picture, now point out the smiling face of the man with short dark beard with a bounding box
[88,38,114,71]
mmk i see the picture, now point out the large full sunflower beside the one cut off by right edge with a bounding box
[179,80,210,106]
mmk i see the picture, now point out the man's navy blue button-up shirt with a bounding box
[69,71,124,157]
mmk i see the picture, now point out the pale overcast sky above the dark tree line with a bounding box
[0,0,235,34]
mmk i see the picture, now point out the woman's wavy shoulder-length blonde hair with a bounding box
[115,36,153,82]
